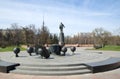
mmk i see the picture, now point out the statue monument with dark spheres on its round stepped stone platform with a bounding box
[0,23,120,76]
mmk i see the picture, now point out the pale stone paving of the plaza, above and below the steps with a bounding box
[0,47,120,79]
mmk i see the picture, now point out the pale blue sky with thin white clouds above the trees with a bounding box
[0,0,120,35]
